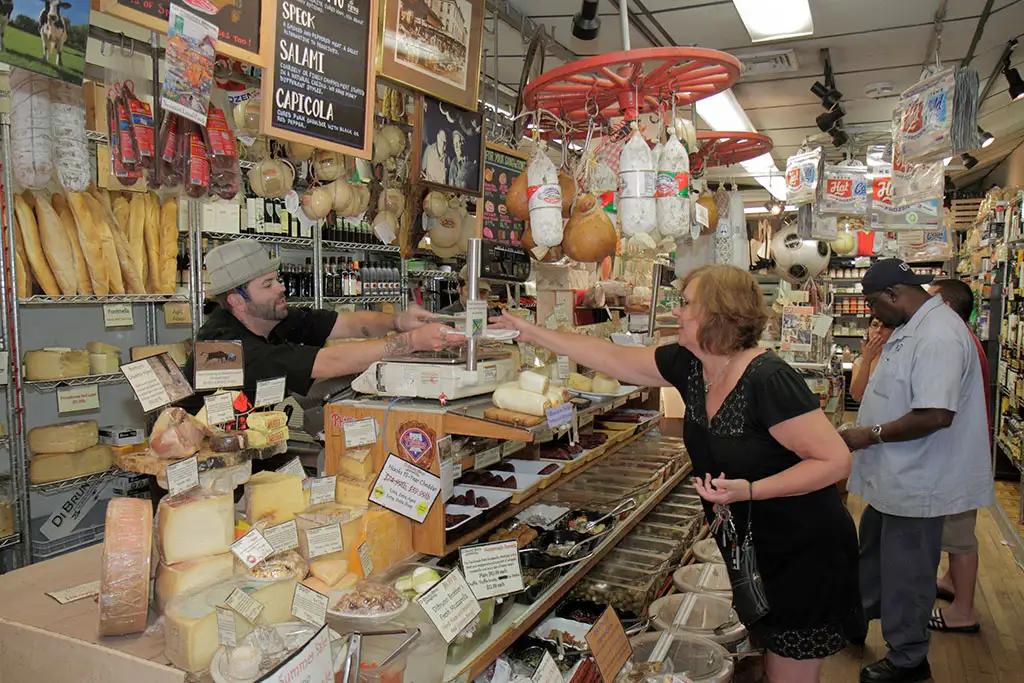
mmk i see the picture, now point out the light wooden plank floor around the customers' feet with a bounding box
[821,496,1024,683]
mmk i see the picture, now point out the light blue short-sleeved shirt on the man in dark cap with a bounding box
[849,295,995,517]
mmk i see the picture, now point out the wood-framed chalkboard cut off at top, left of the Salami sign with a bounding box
[99,0,264,67]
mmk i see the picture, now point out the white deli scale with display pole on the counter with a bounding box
[352,238,529,400]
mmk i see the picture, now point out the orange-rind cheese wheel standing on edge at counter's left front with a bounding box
[99,498,153,636]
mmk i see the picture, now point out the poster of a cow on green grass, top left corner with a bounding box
[0,0,89,85]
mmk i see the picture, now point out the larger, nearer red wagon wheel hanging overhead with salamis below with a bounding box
[523,47,740,123]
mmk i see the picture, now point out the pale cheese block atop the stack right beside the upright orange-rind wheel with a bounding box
[157,488,234,564]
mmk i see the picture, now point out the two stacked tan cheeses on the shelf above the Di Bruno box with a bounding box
[29,420,114,483]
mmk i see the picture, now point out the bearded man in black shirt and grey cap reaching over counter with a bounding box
[184,239,465,409]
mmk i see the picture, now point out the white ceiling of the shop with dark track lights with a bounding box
[480,0,1024,186]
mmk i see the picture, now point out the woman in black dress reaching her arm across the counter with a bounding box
[493,265,863,683]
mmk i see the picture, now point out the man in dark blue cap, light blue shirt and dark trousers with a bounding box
[843,259,994,683]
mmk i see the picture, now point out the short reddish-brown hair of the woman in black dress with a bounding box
[682,265,768,355]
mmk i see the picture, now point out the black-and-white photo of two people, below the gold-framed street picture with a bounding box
[413,95,484,195]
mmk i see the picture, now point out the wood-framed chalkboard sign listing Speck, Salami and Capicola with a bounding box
[260,0,380,159]
